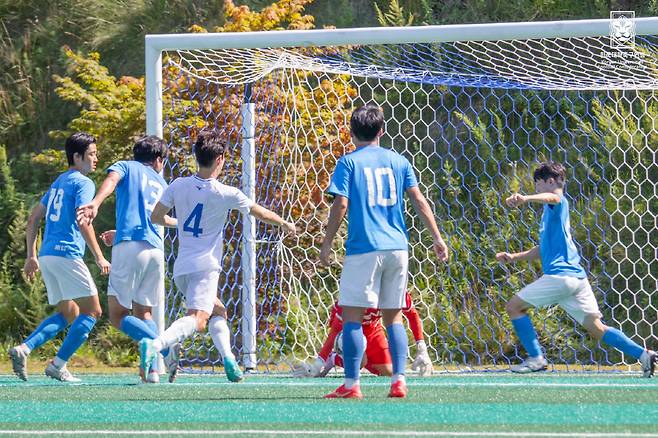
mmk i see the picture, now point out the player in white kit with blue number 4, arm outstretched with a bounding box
[145,131,295,382]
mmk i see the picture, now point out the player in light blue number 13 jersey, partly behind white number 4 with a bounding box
[78,135,180,383]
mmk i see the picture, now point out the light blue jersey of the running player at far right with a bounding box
[539,196,587,278]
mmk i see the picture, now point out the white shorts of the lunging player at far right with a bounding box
[517,275,602,324]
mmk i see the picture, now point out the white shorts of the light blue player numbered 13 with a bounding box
[107,240,164,309]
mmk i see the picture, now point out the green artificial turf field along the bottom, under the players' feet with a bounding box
[0,373,658,437]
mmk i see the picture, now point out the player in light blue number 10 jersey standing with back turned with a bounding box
[320,105,448,398]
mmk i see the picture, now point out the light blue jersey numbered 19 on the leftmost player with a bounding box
[39,169,96,259]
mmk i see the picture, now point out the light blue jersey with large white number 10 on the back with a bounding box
[328,146,418,255]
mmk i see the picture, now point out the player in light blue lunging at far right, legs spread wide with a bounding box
[496,162,658,377]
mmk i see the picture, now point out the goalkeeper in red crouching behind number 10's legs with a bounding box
[293,292,433,377]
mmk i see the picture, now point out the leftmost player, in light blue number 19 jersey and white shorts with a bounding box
[9,132,110,382]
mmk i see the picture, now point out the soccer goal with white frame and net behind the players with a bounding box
[146,17,658,371]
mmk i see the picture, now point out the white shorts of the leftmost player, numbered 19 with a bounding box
[39,256,98,305]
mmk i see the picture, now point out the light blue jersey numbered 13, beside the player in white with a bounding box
[107,161,167,249]
